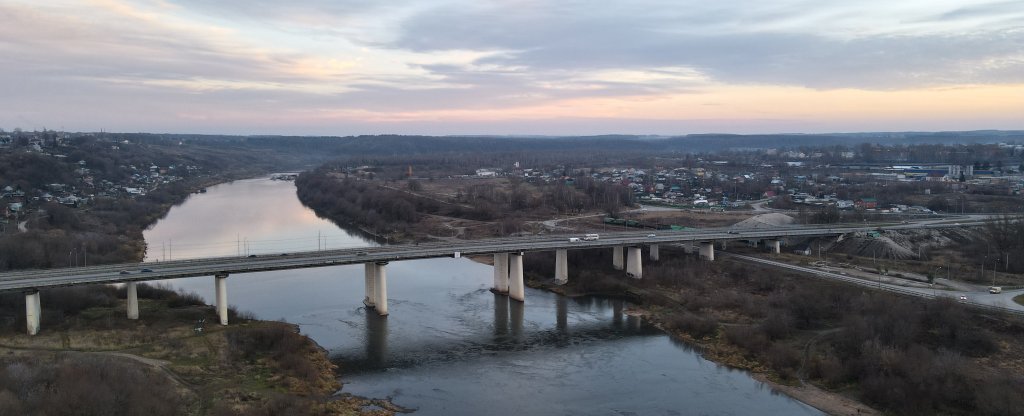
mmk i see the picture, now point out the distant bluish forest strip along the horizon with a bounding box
[104,130,1024,156]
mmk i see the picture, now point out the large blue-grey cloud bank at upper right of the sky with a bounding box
[382,4,1024,89]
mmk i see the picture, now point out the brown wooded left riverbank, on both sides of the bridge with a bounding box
[0,132,391,415]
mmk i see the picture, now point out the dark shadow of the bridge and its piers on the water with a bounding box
[332,294,667,375]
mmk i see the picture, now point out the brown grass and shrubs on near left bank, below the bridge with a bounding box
[0,284,391,416]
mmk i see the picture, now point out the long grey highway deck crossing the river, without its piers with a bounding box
[0,218,983,292]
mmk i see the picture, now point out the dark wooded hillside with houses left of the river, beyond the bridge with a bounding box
[0,135,319,272]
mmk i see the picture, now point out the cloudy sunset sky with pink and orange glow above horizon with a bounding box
[0,0,1024,135]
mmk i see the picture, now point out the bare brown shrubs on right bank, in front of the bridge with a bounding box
[524,248,1024,416]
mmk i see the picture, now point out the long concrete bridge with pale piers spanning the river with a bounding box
[0,219,985,335]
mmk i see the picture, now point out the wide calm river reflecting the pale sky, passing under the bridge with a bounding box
[145,178,821,415]
